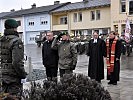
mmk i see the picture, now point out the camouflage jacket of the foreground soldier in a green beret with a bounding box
[0,29,27,83]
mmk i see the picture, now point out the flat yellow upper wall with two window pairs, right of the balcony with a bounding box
[70,7,111,30]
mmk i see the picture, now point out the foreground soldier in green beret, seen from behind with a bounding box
[0,19,27,98]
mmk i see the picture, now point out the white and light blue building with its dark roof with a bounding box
[1,2,69,44]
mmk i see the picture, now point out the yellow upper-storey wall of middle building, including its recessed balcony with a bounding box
[51,7,111,32]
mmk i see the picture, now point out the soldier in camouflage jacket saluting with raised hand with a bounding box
[52,32,77,77]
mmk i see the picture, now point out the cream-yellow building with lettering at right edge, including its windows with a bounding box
[111,0,133,35]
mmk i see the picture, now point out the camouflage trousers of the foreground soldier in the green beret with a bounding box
[2,82,23,100]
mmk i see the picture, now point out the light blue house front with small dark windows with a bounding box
[25,14,50,44]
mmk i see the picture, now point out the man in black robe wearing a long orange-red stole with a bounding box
[106,31,121,85]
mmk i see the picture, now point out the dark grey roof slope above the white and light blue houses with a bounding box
[3,2,70,18]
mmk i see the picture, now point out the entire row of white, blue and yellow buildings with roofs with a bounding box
[0,0,133,44]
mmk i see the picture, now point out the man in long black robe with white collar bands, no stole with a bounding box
[87,32,106,82]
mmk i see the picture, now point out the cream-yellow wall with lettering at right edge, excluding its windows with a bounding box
[111,0,133,35]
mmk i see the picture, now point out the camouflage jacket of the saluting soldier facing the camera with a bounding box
[52,37,77,69]
